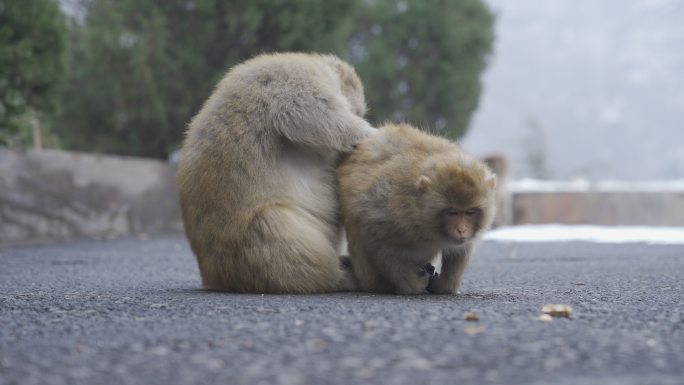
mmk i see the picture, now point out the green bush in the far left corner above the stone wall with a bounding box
[0,0,66,143]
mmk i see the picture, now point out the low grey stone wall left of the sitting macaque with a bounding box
[0,148,182,245]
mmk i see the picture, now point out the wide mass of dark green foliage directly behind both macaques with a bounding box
[53,0,493,157]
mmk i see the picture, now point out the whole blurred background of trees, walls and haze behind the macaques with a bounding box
[0,0,684,242]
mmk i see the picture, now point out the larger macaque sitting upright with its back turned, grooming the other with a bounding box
[177,53,376,293]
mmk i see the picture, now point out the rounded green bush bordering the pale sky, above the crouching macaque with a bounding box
[350,0,493,138]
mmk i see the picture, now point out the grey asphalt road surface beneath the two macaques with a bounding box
[0,232,684,385]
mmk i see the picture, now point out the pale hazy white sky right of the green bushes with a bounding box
[463,0,684,180]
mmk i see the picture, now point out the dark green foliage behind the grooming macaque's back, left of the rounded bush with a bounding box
[59,0,356,157]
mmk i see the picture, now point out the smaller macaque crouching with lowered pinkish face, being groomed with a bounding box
[337,124,496,294]
